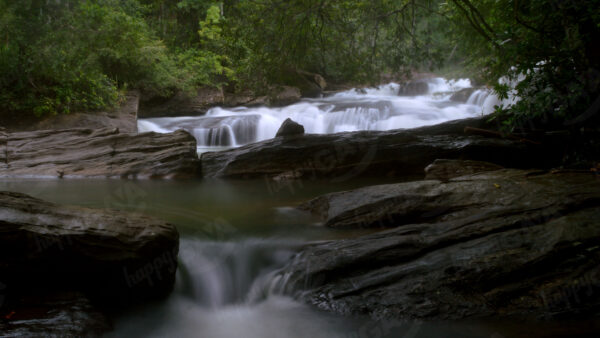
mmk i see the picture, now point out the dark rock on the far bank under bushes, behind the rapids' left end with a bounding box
[138,87,225,118]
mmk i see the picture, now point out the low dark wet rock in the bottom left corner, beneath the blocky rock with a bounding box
[0,292,112,337]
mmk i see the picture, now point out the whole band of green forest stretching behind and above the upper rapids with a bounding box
[0,0,600,128]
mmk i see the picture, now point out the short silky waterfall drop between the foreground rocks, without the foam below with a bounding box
[175,239,298,308]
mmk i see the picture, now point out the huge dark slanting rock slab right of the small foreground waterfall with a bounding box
[274,170,600,320]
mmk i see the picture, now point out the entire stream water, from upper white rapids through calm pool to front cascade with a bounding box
[0,78,536,338]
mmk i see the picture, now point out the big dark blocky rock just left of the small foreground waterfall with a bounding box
[0,192,179,307]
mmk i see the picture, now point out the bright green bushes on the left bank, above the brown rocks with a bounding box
[0,0,228,116]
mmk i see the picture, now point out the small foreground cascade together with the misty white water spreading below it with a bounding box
[108,239,366,338]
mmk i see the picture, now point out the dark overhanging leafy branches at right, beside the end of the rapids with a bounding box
[442,0,600,128]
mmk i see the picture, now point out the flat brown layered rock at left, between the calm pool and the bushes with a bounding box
[0,129,199,178]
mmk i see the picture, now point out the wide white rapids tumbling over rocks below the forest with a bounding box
[138,78,504,152]
